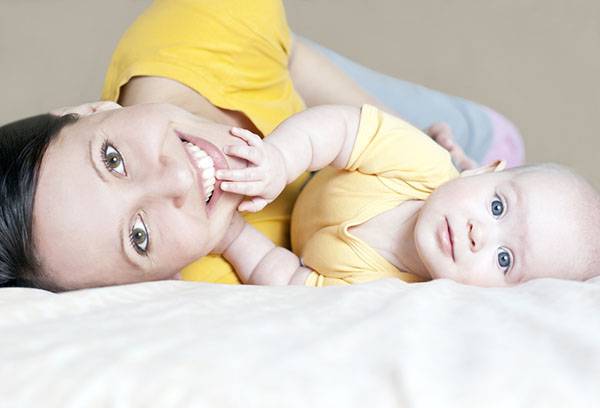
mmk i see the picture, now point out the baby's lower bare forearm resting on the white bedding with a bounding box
[222,214,311,285]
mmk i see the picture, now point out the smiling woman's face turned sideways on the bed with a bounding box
[33,104,246,289]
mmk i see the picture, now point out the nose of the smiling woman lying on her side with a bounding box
[150,156,194,207]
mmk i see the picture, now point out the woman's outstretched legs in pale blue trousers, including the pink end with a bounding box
[307,40,525,166]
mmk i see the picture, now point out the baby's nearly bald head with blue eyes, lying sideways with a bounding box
[415,164,600,286]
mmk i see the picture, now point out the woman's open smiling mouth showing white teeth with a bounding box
[176,131,229,215]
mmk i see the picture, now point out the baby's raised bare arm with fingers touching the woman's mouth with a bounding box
[216,105,360,211]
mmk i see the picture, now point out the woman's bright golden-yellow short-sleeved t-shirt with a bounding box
[102,0,305,283]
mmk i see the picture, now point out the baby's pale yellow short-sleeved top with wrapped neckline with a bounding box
[292,105,458,286]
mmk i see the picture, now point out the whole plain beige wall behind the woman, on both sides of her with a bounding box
[0,0,600,186]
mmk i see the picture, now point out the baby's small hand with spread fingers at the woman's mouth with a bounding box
[216,128,287,212]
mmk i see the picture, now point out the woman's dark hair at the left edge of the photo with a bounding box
[0,114,78,287]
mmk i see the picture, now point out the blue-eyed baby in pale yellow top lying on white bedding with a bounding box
[217,105,600,286]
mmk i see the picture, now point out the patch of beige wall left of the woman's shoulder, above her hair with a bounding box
[0,0,150,119]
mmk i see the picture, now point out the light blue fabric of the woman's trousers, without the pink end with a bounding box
[303,38,493,163]
